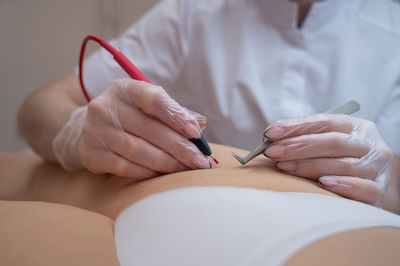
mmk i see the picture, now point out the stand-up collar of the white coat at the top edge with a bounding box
[253,0,363,31]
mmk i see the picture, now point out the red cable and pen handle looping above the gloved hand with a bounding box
[79,35,151,102]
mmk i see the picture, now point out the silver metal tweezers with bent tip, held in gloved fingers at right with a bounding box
[232,101,360,165]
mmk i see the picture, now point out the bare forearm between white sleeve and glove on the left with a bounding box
[18,74,85,161]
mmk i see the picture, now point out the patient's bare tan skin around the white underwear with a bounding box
[0,145,400,266]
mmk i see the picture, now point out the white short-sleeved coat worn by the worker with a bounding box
[84,0,400,154]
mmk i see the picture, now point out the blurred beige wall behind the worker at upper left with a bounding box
[0,0,159,151]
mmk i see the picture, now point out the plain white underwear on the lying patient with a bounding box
[115,187,400,266]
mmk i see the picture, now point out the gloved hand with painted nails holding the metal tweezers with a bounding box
[264,114,393,205]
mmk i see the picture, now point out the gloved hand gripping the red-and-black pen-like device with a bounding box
[53,79,211,179]
